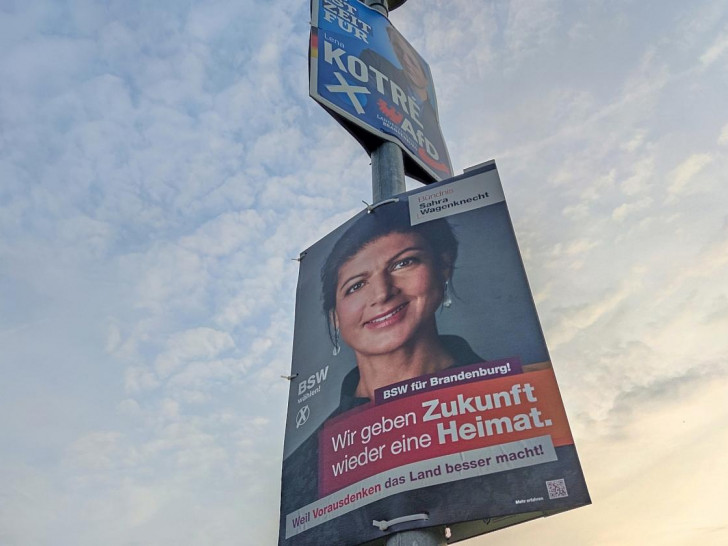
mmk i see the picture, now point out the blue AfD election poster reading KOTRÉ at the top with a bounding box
[309,0,453,183]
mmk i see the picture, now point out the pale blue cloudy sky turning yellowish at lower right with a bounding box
[0,0,728,546]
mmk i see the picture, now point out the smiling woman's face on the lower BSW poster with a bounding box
[334,233,449,356]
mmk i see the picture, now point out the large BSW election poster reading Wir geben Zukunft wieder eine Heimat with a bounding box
[279,162,590,545]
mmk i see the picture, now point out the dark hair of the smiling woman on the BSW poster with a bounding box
[321,198,458,341]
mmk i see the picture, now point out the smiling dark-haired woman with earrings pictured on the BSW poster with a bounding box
[321,201,482,411]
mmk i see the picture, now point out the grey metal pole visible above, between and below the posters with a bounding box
[365,0,447,546]
